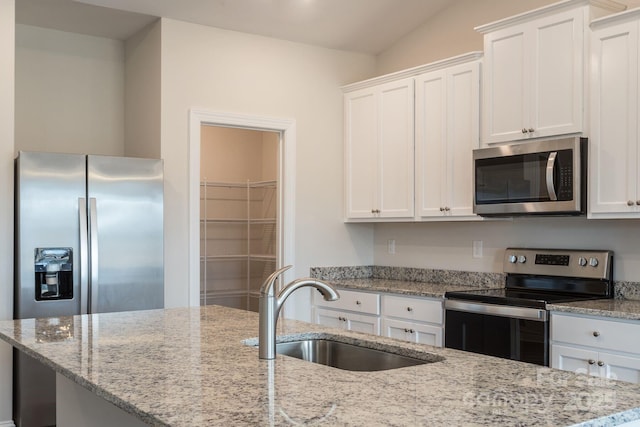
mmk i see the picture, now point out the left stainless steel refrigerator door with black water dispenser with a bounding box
[14,152,86,319]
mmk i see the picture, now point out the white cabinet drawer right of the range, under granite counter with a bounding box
[551,313,640,354]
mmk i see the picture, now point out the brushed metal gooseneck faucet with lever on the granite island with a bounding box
[258,265,340,359]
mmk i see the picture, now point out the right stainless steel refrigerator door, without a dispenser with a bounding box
[87,156,164,313]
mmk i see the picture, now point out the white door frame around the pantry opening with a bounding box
[189,108,296,307]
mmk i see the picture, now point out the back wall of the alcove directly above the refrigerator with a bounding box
[15,25,124,155]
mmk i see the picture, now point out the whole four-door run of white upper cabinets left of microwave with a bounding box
[343,52,482,222]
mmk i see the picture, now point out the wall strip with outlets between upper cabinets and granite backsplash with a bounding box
[374,221,640,282]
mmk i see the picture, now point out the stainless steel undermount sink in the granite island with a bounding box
[276,339,444,371]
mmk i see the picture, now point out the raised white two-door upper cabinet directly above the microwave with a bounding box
[476,0,624,145]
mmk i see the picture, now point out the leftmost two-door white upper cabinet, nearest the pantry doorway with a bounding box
[344,78,414,220]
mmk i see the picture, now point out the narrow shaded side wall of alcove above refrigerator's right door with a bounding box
[124,21,161,159]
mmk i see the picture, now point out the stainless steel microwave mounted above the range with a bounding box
[473,137,587,216]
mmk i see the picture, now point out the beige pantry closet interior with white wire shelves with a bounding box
[200,125,280,311]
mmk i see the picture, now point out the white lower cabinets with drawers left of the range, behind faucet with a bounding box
[313,289,444,347]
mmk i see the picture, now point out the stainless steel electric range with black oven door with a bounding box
[445,248,613,366]
